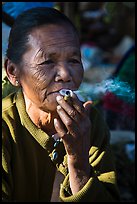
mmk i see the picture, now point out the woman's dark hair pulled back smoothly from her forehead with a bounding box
[6,7,78,64]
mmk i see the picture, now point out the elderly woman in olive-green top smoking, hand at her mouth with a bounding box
[2,8,119,202]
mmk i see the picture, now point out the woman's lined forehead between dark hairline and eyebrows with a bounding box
[26,26,80,56]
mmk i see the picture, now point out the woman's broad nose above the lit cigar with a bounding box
[55,63,72,82]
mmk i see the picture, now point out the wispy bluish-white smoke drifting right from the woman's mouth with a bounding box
[80,77,135,103]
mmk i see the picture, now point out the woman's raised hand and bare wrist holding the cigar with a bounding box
[54,94,92,194]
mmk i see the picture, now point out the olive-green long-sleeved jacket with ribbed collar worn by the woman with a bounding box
[2,91,119,202]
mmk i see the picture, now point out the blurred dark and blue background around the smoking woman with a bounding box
[2,2,135,202]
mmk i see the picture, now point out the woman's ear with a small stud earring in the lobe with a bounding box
[4,58,19,86]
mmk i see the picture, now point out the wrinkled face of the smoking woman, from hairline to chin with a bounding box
[20,25,83,111]
